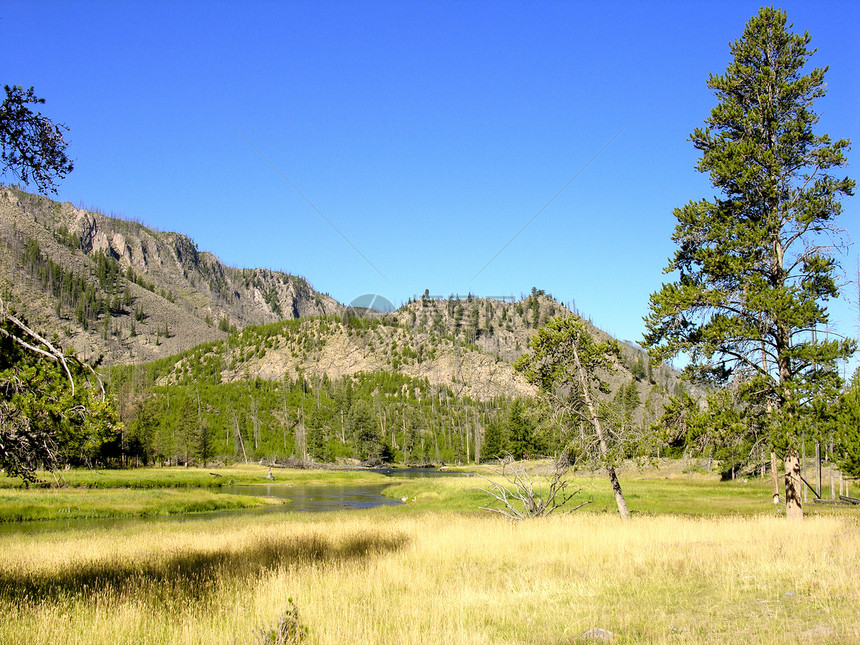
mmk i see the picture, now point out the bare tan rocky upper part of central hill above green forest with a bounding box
[133,292,678,410]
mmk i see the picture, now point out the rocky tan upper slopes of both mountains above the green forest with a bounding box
[0,186,677,416]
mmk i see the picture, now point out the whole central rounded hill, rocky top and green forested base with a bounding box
[111,290,692,464]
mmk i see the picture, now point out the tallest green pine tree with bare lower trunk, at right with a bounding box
[645,7,854,516]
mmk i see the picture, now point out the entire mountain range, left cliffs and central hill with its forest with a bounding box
[0,187,696,463]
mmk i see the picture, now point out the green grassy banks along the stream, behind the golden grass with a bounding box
[0,461,848,523]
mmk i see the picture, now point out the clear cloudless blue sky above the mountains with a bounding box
[0,0,860,358]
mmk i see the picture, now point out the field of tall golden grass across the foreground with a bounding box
[0,511,860,645]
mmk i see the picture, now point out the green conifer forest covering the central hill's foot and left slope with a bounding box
[110,318,660,465]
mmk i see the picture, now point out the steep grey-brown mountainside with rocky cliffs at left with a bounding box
[0,186,342,364]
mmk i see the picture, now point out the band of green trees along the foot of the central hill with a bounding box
[113,368,539,464]
